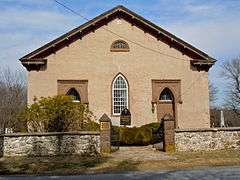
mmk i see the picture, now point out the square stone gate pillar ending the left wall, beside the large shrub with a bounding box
[99,114,111,154]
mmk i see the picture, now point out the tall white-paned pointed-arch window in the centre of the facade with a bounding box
[112,74,128,115]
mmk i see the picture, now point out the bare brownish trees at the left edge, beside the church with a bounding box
[0,68,27,133]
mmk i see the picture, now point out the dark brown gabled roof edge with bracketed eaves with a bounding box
[20,6,216,65]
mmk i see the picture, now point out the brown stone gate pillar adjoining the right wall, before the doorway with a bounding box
[162,114,175,152]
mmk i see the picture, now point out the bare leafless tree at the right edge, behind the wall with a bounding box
[222,56,240,116]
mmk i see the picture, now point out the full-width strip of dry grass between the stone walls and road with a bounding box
[0,150,240,175]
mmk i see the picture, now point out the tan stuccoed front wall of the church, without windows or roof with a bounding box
[21,5,215,128]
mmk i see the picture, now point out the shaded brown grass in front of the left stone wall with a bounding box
[0,156,107,174]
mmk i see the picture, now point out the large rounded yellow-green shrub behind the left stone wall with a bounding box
[18,95,98,132]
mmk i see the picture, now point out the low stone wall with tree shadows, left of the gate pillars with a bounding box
[0,131,100,156]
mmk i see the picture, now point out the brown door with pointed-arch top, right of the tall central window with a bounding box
[157,87,175,124]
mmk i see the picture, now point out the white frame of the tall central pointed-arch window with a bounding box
[111,73,129,116]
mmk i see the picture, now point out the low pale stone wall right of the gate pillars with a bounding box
[175,127,240,151]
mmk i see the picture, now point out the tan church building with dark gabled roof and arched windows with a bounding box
[20,6,216,128]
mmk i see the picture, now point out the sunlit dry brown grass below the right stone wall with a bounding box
[136,150,240,170]
